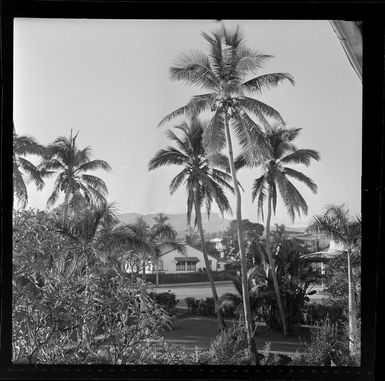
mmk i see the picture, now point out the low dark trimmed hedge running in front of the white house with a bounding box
[146,270,237,284]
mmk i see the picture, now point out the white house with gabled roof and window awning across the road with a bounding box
[146,244,225,274]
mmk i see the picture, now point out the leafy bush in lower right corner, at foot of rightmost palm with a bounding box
[290,319,359,366]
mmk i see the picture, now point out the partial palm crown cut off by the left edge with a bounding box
[13,127,44,208]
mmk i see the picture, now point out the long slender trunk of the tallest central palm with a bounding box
[224,113,257,365]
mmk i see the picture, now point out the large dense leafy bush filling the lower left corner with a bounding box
[12,211,171,364]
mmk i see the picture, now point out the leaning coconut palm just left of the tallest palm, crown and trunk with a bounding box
[149,118,233,329]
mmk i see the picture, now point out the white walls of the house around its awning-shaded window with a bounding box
[161,245,219,274]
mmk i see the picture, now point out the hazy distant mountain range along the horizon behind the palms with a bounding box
[118,213,305,237]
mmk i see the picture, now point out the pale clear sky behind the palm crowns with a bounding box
[14,19,362,226]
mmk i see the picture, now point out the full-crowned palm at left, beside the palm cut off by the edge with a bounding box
[40,130,111,225]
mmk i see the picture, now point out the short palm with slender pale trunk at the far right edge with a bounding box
[306,205,361,354]
